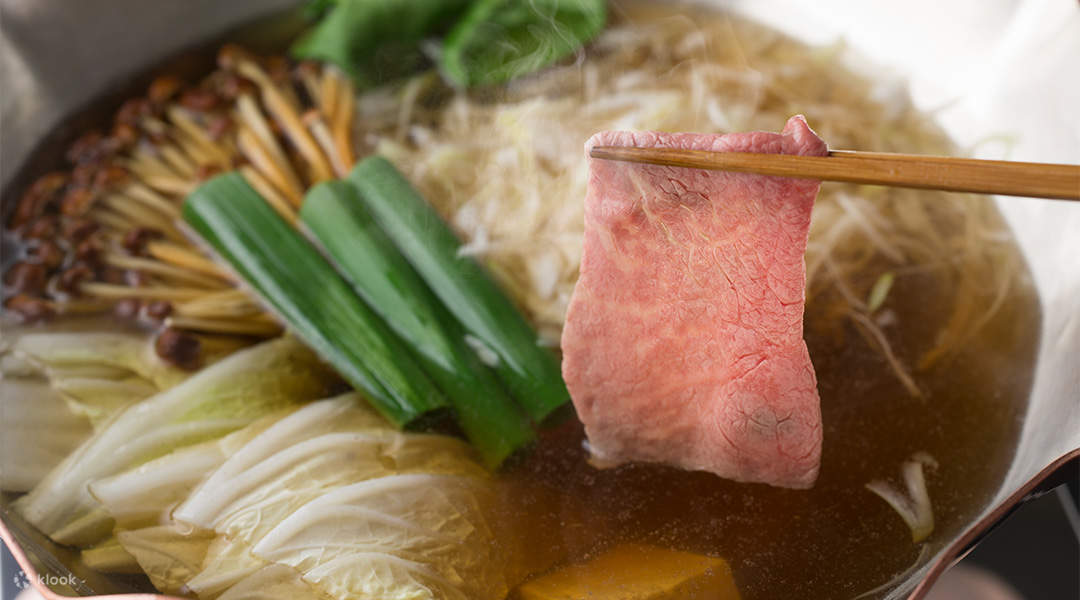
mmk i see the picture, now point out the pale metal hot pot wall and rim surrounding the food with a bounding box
[0,0,1080,599]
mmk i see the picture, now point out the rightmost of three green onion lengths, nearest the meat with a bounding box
[348,156,570,422]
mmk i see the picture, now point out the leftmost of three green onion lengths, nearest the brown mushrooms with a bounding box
[184,173,446,426]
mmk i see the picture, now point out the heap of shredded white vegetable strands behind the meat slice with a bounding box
[357,3,1017,388]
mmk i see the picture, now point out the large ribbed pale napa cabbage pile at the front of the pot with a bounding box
[91,393,510,600]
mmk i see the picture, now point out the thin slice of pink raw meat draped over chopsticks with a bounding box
[562,117,827,488]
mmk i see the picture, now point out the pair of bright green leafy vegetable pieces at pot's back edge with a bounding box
[293,0,607,87]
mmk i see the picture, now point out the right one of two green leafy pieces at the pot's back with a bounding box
[442,0,607,87]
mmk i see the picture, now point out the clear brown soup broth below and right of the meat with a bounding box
[496,228,1040,600]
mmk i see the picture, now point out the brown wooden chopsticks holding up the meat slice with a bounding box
[589,146,1080,201]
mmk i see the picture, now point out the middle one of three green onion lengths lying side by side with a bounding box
[300,181,534,467]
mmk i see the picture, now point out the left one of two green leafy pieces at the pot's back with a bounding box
[293,0,469,86]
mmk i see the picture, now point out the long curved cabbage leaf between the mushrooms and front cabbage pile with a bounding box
[16,338,333,546]
